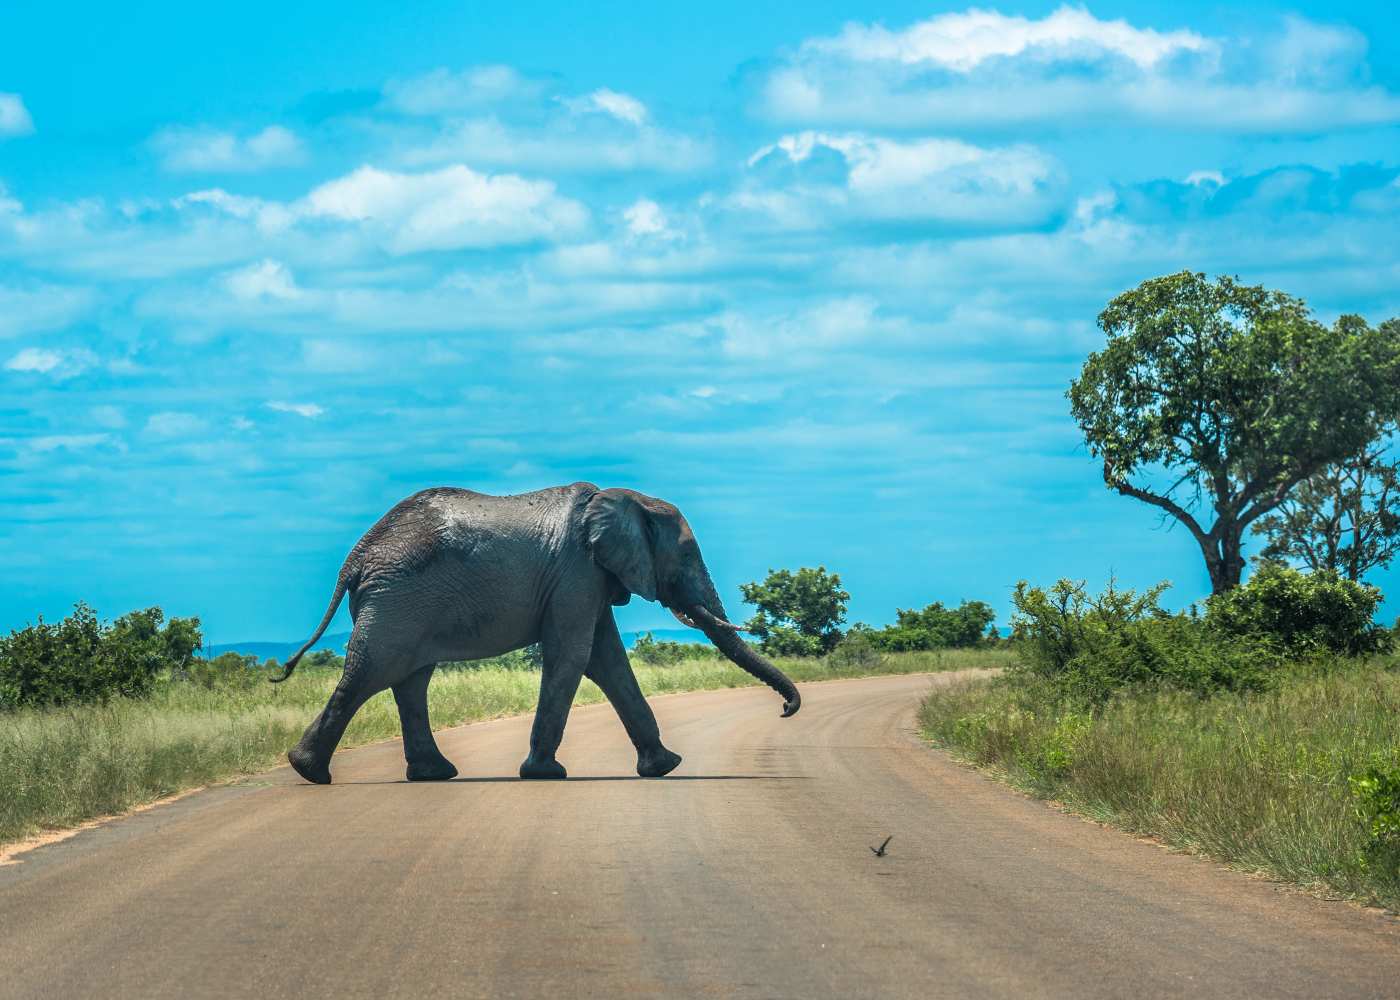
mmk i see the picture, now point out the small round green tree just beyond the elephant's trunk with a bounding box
[739,566,851,657]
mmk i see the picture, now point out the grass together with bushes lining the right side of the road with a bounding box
[920,571,1400,909]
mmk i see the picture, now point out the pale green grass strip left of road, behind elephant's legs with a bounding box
[0,650,1007,842]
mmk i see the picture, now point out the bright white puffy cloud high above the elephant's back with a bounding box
[301,165,588,254]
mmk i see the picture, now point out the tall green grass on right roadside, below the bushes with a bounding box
[921,660,1400,909]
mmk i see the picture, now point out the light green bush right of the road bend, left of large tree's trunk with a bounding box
[1011,580,1281,704]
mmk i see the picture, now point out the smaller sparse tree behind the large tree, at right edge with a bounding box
[1254,440,1400,583]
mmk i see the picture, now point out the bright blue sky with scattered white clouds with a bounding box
[0,1,1400,641]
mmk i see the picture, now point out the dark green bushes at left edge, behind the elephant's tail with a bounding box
[0,604,203,709]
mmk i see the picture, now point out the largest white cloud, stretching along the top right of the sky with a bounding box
[760,7,1400,132]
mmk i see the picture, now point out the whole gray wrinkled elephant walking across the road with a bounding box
[277,483,801,784]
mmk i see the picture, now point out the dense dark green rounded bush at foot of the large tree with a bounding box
[1205,563,1390,657]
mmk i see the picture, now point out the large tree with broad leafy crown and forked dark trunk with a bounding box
[1067,272,1400,594]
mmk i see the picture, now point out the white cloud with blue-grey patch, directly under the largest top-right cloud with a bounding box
[729,132,1060,228]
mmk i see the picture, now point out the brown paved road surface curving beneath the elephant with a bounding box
[0,675,1400,1000]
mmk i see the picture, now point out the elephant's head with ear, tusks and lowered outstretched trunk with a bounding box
[584,489,802,717]
